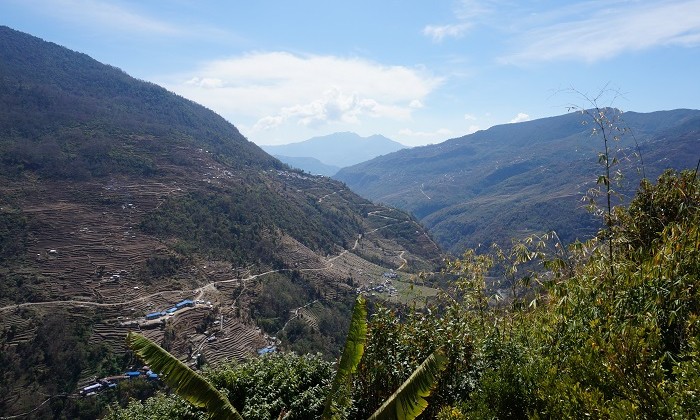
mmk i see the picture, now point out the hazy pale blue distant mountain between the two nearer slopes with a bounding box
[261,132,406,171]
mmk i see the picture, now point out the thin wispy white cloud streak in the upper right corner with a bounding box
[501,0,700,64]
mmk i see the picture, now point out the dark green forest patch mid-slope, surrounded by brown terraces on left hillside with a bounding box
[140,185,361,268]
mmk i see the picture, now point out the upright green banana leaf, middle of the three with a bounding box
[321,295,367,419]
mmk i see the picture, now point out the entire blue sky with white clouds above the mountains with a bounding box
[0,0,700,146]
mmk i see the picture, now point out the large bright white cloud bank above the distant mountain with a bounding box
[162,52,442,131]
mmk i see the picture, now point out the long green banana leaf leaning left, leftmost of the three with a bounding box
[126,332,243,420]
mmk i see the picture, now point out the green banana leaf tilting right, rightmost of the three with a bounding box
[369,349,447,420]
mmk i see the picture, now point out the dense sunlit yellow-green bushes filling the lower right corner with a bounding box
[464,172,700,418]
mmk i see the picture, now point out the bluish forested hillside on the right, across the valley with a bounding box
[334,110,700,253]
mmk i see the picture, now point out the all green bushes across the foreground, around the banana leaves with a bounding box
[109,172,700,420]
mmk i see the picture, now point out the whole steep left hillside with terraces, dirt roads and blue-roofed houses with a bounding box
[0,27,440,418]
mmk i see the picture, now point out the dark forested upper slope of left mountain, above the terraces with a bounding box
[0,27,282,179]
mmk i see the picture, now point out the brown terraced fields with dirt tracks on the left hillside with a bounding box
[0,146,442,416]
